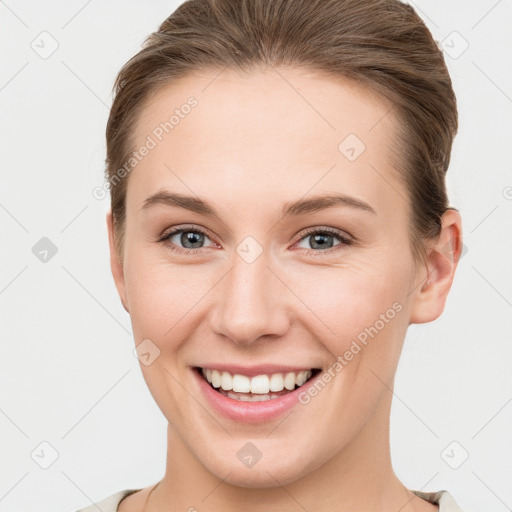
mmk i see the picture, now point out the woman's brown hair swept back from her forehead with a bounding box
[106,0,458,257]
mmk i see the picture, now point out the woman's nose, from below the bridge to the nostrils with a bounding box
[210,249,290,345]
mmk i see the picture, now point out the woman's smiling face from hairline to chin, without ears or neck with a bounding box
[110,69,430,486]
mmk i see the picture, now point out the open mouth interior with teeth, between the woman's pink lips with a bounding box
[195,367,321,402]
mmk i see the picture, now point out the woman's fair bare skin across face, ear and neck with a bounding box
[107,68,462,512]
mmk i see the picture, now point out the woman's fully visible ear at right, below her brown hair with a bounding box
[410,209,462,324]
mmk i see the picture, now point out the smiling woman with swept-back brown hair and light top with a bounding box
[78,0,462,512]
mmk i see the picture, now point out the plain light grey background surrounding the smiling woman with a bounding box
[0,0,512,512]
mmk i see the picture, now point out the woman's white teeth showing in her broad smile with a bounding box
[202,368,312,394]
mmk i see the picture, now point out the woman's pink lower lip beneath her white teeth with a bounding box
[192,369,318,423]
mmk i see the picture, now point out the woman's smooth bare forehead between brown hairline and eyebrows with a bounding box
[127,68,399,219]
